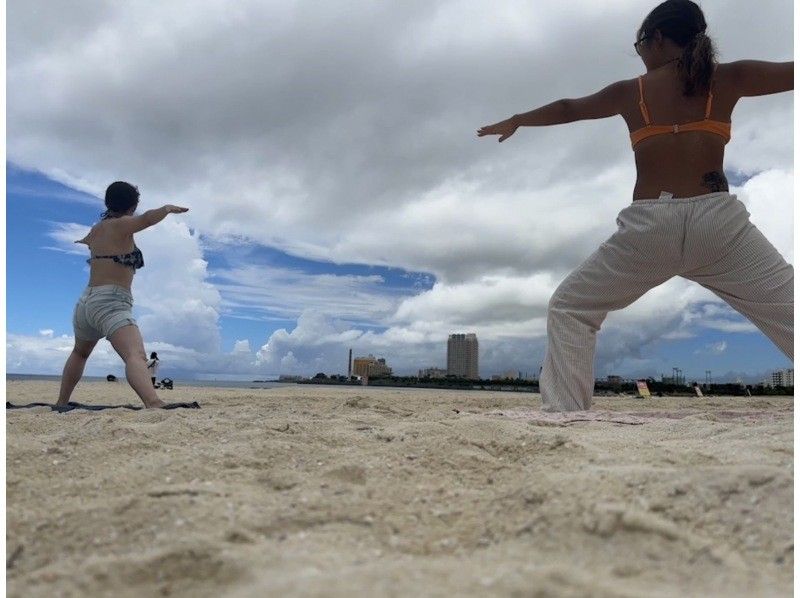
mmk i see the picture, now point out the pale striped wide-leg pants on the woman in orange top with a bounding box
[539,192,794,411]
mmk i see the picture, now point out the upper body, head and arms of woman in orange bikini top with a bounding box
[478,0,794,199]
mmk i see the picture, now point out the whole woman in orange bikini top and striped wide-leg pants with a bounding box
[478,0,794,411]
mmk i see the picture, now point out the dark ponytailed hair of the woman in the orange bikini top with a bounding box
[636,0,717,96]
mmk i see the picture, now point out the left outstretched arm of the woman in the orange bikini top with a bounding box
[478,81,629,141]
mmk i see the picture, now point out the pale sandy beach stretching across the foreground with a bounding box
[6,381,794,598]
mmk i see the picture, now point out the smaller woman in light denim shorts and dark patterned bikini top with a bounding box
[56,181,188,407]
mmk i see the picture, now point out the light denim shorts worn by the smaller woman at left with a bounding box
[72,284,136,341]
